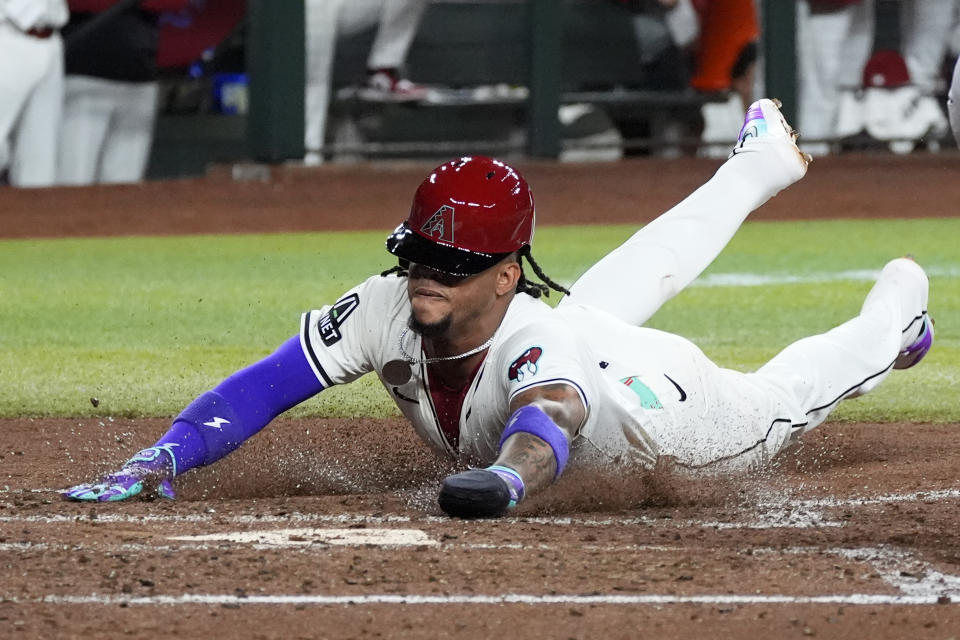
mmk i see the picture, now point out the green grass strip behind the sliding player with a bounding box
[0,219,960,422]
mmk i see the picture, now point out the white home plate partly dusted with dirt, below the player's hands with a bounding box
[169,529,439,547]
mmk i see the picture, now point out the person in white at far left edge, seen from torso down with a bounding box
[0,0,68,187]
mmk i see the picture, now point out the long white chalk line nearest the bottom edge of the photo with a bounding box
[28,593,960,606]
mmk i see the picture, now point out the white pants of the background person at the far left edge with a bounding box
[0,22,63,187]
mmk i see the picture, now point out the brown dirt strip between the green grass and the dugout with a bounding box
[0,153,960,238]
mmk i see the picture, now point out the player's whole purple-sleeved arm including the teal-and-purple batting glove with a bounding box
[61,336,323,502]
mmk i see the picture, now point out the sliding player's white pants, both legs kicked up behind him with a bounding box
[561,139,928,470]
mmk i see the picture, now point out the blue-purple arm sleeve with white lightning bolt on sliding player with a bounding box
[157,336,323,473]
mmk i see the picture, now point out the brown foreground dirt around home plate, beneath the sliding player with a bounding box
[0,420,960,640]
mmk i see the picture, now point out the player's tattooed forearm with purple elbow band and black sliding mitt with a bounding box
[439,384,586,518]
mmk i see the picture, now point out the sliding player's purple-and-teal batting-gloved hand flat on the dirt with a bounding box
[60,447,176,502]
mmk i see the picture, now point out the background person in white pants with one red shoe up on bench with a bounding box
[304,0,429,165]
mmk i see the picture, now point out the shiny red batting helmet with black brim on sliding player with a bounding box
[387,156,534,276]
